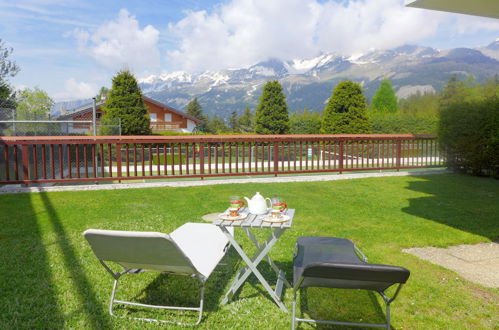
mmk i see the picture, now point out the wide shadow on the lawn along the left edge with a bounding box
[0,194,64,329]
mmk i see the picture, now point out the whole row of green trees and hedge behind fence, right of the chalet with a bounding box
[186,75,499,134]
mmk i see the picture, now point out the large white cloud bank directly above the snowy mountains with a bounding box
[167,0,498,71]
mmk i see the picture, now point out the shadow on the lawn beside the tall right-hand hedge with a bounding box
[403,174,499,241]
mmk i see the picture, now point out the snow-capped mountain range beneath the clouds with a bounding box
[56,39,499,117]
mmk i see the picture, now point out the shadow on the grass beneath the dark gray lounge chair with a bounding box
[296,288,386,329]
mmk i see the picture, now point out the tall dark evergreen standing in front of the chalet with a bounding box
[102,70,151,135]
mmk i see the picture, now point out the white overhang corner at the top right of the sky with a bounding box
[406,0,499,18]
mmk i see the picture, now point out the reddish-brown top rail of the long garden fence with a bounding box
[0,134,437,145]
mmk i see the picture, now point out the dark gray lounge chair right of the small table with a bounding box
[292,236,410,329]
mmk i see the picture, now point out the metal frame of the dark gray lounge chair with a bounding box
[291,237,409,329]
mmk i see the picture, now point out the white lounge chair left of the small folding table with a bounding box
[83,223,232,325]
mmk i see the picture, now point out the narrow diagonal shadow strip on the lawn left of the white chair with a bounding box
[40,193,111,329]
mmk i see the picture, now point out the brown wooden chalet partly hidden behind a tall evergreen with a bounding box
[57,96,203,133]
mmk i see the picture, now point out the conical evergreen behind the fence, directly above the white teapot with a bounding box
[255,80,289,134]
